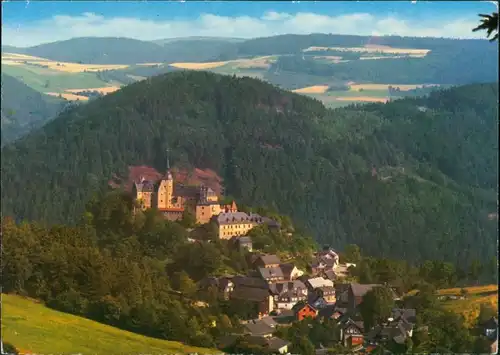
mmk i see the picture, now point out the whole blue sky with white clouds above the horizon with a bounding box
[2,0,498,47]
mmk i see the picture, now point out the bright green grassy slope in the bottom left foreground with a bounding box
[2,294,220,354]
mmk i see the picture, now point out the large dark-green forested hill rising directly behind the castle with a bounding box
[1,72,498,263]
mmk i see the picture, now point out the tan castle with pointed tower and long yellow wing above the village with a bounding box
[133,158,277,239]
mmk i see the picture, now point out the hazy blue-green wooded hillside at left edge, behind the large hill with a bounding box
[1,73,64,145]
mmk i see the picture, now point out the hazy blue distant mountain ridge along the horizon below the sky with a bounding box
[2,33,496,64]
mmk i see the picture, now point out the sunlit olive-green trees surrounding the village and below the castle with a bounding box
[1,191,496,355]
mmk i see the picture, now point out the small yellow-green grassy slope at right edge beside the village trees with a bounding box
[438,285,498,326]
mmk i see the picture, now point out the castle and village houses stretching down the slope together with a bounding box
[134,170,497,355]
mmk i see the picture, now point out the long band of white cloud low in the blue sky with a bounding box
[2,11,484,47]
